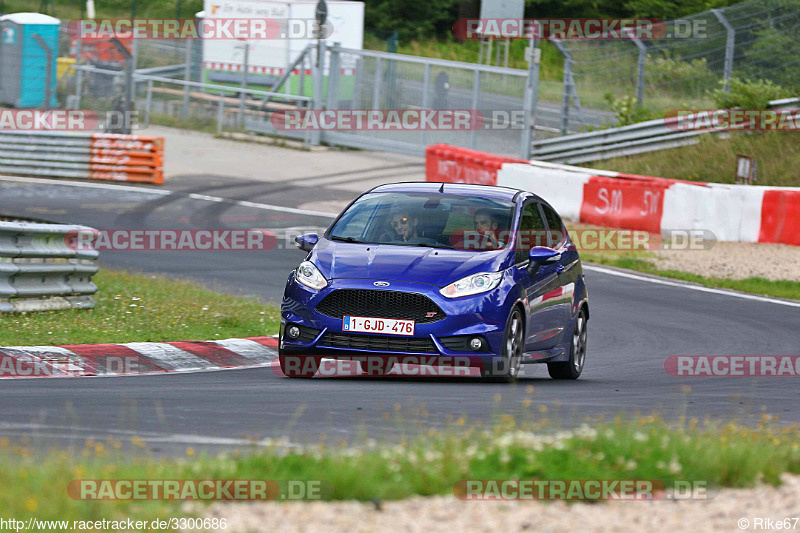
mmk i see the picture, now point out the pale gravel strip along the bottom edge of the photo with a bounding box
[206,475,800,533]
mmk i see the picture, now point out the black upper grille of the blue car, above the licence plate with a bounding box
[317,289,446,324]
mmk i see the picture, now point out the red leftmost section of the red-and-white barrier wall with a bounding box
[425,144,527,185]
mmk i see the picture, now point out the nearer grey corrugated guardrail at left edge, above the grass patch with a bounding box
[0,222,98,312]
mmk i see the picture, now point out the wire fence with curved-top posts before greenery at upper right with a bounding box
[563,0,800,111]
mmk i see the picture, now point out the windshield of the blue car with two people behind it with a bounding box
[328,192,514,251]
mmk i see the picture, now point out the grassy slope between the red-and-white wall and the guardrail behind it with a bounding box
[583,131,800,187]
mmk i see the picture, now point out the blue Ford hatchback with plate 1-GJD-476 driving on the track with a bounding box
[279,182,589,382]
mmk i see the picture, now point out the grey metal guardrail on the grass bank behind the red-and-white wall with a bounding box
[531,98,800,165]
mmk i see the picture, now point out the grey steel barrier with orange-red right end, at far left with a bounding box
[0,130,164,185]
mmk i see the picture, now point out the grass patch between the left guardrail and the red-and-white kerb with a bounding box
[0,268,280,346]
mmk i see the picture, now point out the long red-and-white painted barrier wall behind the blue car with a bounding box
[425,144,800,246]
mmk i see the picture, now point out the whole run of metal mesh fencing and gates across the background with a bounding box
[45,0,800,157]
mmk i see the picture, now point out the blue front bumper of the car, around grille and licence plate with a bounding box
[280,273,511,365]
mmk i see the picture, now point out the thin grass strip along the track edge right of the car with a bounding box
[581,252,800,300]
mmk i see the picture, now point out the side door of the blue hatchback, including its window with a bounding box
[514,201,560,352]
